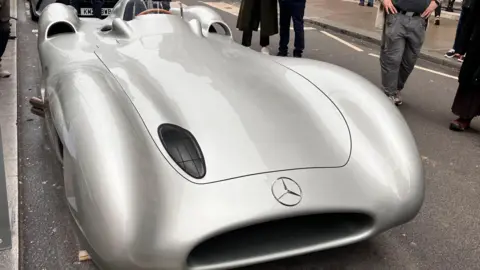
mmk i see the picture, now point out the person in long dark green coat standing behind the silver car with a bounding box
[237,0,278,54]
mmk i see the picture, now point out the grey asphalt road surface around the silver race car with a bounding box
[17,0,480,270]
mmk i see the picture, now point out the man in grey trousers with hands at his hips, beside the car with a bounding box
[380,0,439,106]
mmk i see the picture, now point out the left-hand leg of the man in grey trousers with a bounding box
[380,14,405,98]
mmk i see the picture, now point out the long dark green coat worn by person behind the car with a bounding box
[237,0,278,36]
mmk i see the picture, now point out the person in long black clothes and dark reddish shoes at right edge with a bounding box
[450,1,480,131]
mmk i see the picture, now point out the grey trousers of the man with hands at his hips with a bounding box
[380,13,428,96]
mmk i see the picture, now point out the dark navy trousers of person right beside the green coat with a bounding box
[278,0,306,54]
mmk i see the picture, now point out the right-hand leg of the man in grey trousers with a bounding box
[397,17,426,95]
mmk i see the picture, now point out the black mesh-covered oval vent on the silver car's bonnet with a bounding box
[158,124,206,179]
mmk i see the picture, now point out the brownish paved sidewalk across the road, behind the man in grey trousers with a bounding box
[305,0,461,69]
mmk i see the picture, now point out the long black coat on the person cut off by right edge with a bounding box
[458,1,480,85]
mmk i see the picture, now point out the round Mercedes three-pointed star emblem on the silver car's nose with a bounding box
[272,177,302,206]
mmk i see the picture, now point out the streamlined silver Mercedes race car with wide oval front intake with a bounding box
[32,0,424,270]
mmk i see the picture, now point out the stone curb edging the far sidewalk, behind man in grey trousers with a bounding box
[304,18,462,71]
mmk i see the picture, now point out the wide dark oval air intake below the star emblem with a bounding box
[187,213,374,269]
